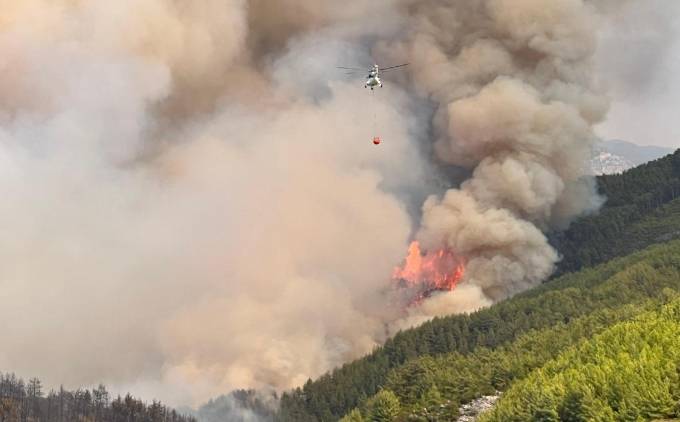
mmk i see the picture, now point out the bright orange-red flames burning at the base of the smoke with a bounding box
[392,242,465,299]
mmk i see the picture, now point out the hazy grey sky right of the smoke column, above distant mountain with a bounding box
[598,0,680,148]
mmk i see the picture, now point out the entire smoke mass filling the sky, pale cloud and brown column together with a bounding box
[0,0,675,405]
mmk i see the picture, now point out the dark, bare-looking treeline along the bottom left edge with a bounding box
[0,374,196,422]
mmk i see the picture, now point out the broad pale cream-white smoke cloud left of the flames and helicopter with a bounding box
[0,0,421,404]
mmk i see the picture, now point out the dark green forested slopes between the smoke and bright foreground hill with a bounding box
[278,151,680,421]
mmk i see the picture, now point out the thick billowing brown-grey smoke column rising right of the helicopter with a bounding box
[382,0,608,326]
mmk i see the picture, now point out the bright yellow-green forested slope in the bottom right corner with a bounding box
[480,300,680,422]
